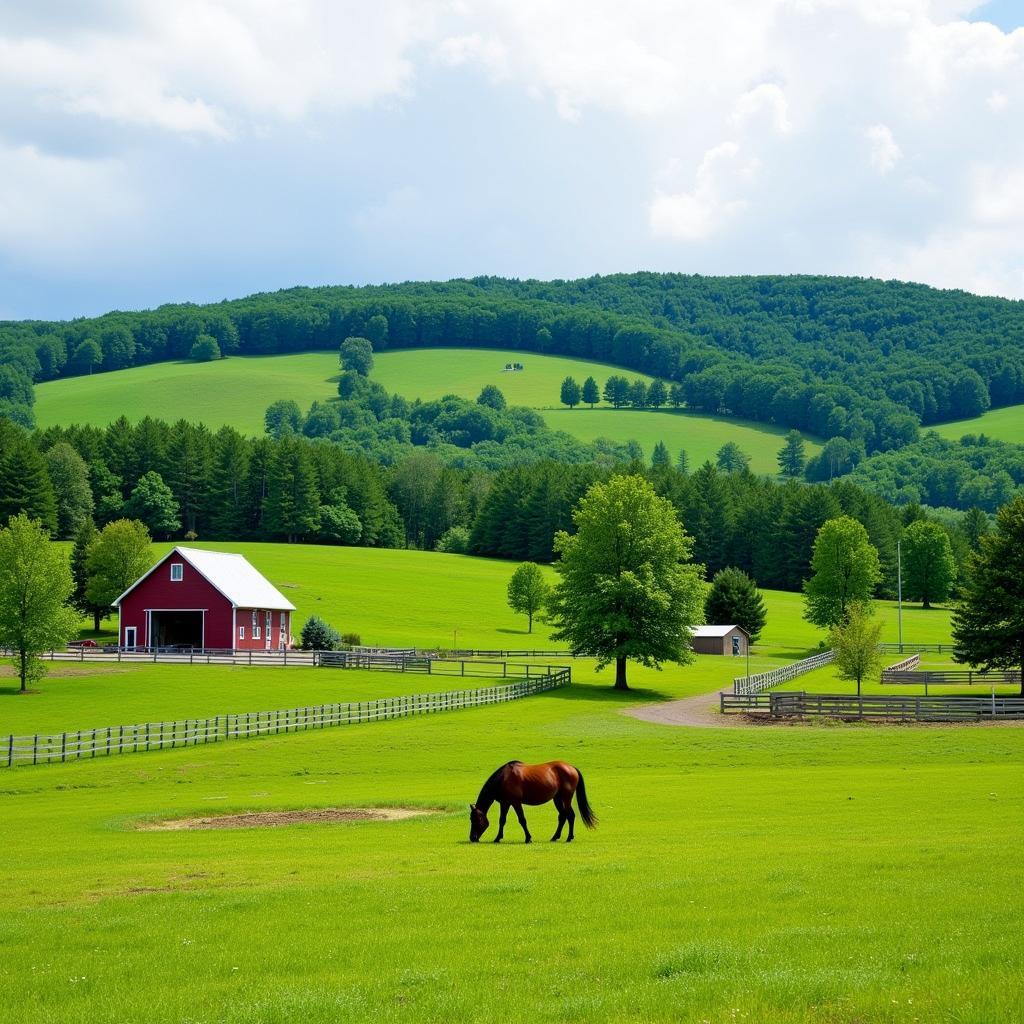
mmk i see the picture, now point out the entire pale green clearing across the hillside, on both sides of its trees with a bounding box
[36,348,820,473]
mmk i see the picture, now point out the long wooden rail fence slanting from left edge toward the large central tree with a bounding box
[0,666,571,768]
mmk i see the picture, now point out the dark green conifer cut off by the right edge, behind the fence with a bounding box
[952,498,1024,695]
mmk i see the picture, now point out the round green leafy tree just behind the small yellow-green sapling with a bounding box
[804,515,882,628]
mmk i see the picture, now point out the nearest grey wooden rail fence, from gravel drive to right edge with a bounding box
[720,690,1024,722]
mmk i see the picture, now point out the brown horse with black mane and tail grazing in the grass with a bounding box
[469,761,597,843]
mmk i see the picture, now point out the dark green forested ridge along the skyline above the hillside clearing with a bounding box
[0,273,1024,454]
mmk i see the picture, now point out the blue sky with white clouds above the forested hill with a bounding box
[0,0,1024,318]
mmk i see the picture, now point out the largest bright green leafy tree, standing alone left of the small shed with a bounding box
[549,476,708,689]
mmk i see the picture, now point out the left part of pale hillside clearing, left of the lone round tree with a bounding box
[35,352,338,434]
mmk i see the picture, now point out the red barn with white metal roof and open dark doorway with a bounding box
[114,548,295,650]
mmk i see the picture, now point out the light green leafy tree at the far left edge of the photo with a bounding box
[0,513,78,693]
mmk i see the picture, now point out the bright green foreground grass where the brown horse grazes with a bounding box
[0,659,1024,1024]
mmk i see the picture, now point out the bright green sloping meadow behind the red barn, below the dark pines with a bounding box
[82,542,949,659]
